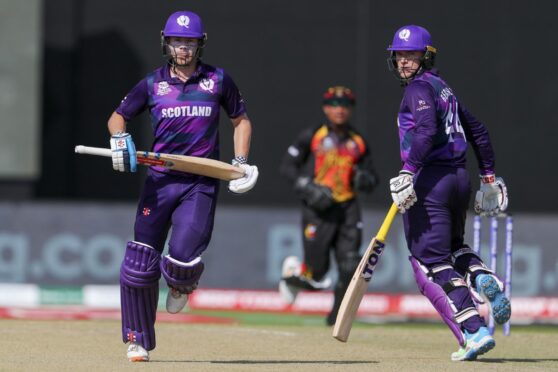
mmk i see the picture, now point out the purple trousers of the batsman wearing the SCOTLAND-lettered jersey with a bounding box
[134,169,219,262]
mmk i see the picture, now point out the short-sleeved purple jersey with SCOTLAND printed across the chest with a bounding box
[116,63,246,173]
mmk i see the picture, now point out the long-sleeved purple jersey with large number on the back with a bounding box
[397,70,494,175]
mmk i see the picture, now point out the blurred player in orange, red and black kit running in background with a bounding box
[279,86,378,325]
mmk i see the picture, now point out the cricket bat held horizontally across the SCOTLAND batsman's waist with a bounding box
[75,146,244,181]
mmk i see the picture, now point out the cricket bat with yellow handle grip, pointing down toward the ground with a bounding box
[333,203,398,342]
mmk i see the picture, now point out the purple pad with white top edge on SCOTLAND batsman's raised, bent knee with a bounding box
[161,255,204,293]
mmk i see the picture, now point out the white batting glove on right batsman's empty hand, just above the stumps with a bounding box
[475,174,508,216]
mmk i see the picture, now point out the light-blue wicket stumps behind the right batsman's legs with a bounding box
[473,214,513,336]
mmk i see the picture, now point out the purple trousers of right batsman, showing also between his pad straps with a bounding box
[403,166,485,333]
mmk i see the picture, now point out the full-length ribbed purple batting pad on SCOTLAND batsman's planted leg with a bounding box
[120,242,161,350]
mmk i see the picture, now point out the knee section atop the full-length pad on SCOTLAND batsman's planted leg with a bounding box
[120,241,161,288]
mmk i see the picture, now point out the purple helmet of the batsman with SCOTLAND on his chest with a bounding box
[161,10,207,64]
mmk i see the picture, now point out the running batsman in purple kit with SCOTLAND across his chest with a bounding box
[108,11,258,362]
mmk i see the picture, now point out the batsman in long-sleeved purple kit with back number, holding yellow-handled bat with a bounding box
[388,25,511,361]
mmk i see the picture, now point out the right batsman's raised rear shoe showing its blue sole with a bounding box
[475,274,511,324]
